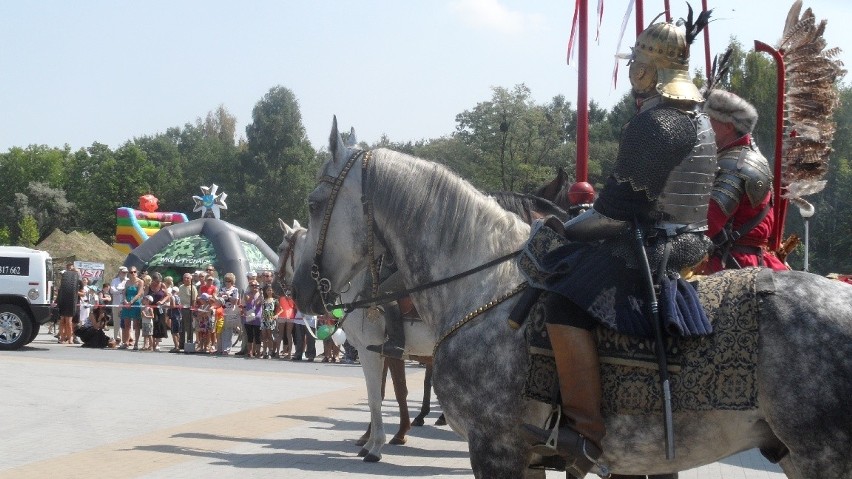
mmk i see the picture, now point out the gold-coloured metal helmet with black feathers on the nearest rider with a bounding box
[631,4,710,102]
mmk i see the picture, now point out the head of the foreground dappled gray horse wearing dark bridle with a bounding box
[292,117,386,314]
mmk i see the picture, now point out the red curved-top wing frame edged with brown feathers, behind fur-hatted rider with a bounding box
[754,40,787,251]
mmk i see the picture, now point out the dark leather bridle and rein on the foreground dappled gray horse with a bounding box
[310,150,521,316]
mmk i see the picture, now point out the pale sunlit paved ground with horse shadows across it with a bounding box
[0,333,784,479]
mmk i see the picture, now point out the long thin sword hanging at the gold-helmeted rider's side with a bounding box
[635,221,674,460]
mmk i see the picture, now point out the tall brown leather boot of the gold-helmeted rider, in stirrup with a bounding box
[523,324,606,477]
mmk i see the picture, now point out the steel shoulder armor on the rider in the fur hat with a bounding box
[711,146,772,216]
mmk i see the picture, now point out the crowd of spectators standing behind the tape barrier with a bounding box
[57,265,355,362]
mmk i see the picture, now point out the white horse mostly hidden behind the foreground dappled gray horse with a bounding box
[278,219,435,462]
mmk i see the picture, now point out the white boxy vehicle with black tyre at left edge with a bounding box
[0,246,53,350]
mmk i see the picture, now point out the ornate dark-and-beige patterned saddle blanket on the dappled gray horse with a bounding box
[524,268,775,415]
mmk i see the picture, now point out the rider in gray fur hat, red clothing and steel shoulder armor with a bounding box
[702,89,789,274]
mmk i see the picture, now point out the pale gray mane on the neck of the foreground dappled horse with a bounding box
[367,148,529,255]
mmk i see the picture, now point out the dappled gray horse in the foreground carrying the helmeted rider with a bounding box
[293,119,852,479]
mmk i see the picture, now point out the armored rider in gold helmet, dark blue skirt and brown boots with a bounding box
[521,12,716,477]
